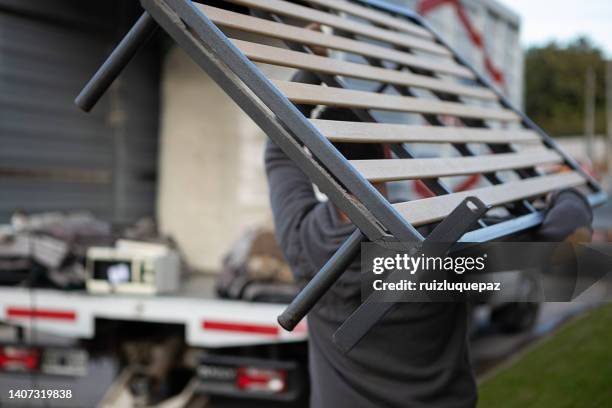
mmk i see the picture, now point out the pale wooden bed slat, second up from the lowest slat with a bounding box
[351,150,562,182]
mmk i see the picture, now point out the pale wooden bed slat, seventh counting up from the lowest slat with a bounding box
[222,0,452,57]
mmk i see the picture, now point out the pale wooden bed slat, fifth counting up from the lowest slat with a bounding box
[232,39,497,100]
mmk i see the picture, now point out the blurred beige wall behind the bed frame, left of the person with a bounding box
[157,47,271,271]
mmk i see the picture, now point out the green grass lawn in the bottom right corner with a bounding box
[478,304,612,408]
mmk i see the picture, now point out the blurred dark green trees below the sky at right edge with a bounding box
[525,37,606,136]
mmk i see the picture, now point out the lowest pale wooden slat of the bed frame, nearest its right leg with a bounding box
[393,171,585,226]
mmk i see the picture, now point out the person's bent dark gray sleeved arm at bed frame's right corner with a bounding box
[536,189,593,242]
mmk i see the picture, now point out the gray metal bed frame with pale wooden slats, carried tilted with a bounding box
[76,0,607,346]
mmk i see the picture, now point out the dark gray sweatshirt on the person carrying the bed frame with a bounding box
[265,137,476,408]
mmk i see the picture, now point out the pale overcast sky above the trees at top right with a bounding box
[500,0,612,58]
